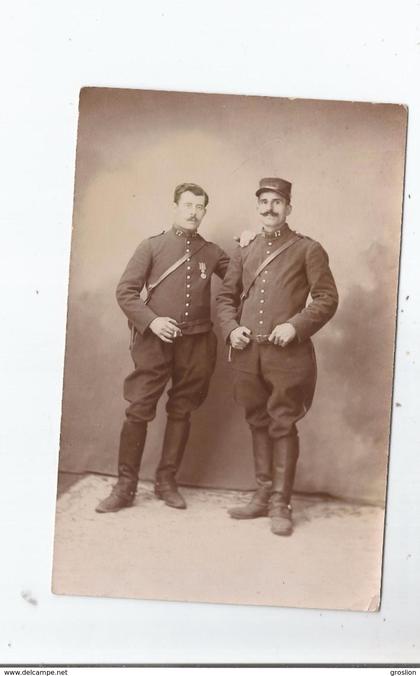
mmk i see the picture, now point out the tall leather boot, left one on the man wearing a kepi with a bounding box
[228,427,273,519]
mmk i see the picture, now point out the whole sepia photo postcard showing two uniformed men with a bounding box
[53,88,407,611]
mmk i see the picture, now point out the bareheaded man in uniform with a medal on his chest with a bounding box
[96,183,229,512]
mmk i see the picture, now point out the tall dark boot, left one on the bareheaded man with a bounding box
[95,420,147,513]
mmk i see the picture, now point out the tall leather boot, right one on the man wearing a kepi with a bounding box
[268,436,299,535]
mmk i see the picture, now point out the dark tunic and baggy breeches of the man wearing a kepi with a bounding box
[217,224,338,438]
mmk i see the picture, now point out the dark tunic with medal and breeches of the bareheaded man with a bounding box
[116,227,229,422]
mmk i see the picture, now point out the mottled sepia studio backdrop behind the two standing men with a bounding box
[60,88,407,503]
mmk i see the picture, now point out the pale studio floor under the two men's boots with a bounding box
[53,475,384,611]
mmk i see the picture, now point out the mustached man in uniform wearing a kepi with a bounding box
[217,178,338,535]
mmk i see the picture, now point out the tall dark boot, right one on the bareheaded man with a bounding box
[155,418,190,509]
